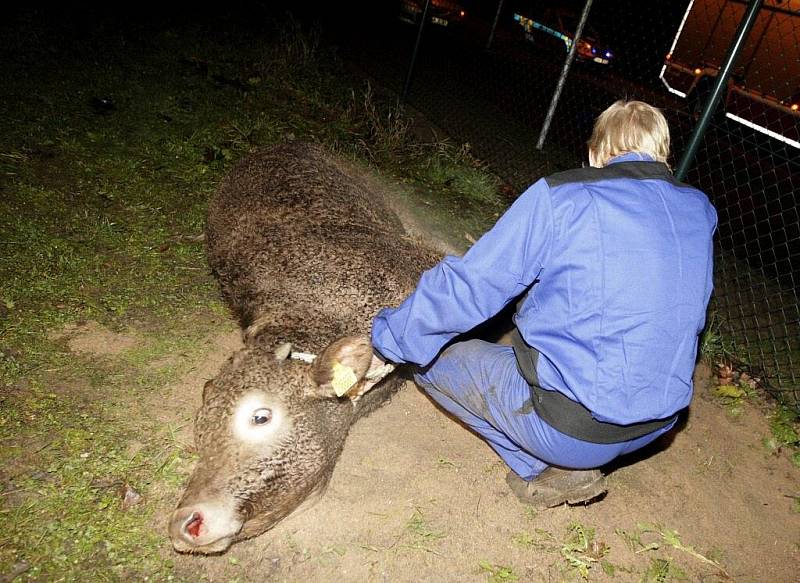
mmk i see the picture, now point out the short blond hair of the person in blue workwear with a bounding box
[589,100,669,167]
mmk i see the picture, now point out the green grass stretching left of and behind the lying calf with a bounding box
[0,4,512,581]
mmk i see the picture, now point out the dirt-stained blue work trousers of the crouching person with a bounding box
[414,340,674,480]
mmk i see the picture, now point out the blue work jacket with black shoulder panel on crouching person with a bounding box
[372,153,717,425]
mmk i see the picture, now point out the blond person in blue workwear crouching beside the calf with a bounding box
[372,101,716,508]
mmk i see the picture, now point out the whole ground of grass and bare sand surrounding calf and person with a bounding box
[0,3,800,583]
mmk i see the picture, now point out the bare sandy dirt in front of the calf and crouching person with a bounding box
[111,169,800,582]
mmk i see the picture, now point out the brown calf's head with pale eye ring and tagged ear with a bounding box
[169,336,390,554]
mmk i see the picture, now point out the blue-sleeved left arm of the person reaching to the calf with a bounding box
[372,180,553,366]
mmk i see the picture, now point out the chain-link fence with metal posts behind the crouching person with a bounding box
[318,0,800,412]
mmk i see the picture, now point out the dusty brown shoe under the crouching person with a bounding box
[506,466,607,510]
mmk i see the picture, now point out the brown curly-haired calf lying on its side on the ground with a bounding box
[169,143,436,553]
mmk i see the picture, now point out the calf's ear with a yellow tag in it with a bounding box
[313,336,394,401]
